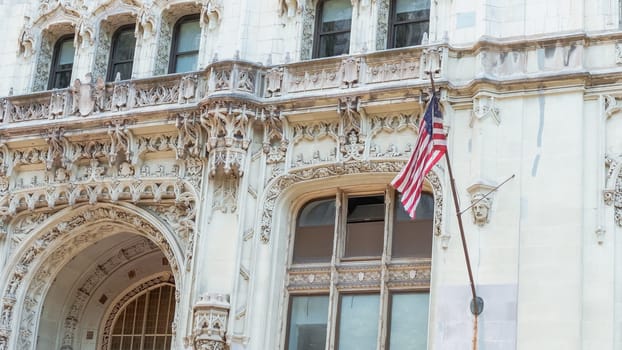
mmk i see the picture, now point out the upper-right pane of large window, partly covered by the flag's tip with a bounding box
[391,193,434,258]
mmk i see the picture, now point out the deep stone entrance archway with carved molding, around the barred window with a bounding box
[2,204,183,350]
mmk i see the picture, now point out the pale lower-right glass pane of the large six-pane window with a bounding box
[389,293,430,350]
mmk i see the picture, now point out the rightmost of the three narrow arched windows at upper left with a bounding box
[169,15,201,73]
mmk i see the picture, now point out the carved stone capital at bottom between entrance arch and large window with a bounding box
[188,293,230,350]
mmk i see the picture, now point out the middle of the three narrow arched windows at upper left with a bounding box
[106,24,136,81]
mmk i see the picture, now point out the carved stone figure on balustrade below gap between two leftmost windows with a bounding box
[71,74,106,117]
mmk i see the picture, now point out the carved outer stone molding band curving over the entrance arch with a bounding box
[0,203,184,350]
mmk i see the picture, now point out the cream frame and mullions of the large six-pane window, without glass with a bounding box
[281,187,437,350]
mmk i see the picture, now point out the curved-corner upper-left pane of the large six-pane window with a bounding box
[293,199,336,263]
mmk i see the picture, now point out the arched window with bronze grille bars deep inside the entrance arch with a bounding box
[109,284,175,350]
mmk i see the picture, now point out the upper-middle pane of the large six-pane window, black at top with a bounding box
[344,196,385,257]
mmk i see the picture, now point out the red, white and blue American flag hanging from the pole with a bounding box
[391,94,447,219]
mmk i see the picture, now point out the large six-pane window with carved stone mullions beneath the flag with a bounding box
[285,190,434,350]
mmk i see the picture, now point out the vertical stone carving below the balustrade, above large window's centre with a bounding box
[337,96,365,159]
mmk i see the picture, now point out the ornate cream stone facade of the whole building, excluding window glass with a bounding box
[0,0,622,350]
